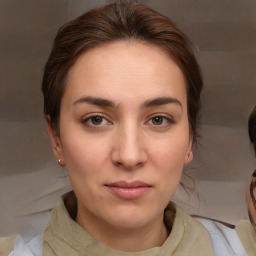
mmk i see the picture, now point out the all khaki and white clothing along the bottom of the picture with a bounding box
[0,194,256,256]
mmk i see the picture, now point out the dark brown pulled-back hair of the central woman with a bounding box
[42,0,203,142]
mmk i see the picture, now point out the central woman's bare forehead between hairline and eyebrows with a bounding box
[64,42,186,105]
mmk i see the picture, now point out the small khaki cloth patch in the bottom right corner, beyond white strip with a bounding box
[236,220,256,256]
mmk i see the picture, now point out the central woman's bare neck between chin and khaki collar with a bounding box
[76,205,168,252]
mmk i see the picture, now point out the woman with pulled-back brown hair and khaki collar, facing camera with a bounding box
[0,1,252,256]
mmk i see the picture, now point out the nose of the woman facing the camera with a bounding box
[111,124,148,170]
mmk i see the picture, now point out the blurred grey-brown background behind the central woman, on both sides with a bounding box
[0,0,256,239]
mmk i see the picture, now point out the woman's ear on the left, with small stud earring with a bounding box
[46,116,65,166]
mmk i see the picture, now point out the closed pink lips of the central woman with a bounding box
[106,181,152,200]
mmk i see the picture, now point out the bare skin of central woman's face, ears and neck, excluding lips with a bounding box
[48,42,193,251]
